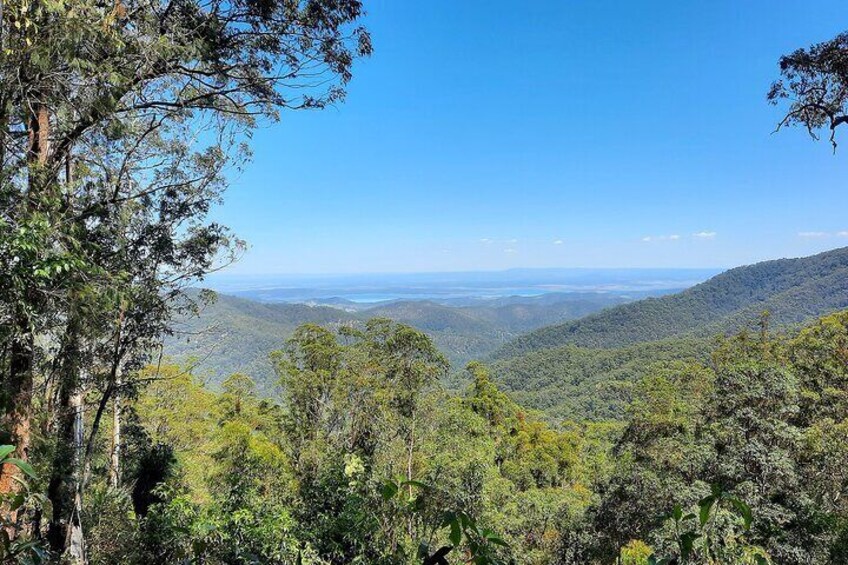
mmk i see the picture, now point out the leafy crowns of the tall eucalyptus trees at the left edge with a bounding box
[0,0,371,550]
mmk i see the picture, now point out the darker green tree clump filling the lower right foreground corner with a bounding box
[564,313,848,565]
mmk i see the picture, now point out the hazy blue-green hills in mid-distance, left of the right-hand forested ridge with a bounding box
[165,293,638,391]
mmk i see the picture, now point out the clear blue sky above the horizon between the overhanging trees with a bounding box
[216,0,848,274]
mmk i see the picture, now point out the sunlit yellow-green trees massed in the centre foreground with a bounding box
[91,319,609,564]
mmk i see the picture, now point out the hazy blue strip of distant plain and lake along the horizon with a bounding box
[200,269,721,304]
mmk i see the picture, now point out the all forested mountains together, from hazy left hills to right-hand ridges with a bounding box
[166,248,848,420]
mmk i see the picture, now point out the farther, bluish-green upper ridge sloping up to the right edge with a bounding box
[493,248,848,359]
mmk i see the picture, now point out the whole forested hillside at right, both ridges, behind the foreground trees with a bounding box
[489,248,848,420]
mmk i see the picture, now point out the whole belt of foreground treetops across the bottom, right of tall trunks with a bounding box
[61,312,848,565]
